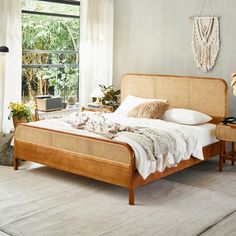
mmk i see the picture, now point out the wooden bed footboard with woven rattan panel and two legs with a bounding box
[14,125,135,205]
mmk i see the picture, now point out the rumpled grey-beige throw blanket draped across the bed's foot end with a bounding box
[64,112,197,178]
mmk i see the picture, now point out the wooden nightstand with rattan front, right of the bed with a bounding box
[216,124,236,171]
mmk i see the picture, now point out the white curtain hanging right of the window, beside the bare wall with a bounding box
[79,0,114,105]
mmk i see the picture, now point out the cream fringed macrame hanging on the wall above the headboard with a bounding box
[190,0,220,72]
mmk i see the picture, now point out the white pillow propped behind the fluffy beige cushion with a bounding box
[115,95,167,114]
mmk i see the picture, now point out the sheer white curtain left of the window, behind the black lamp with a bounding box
[0,0,22,133]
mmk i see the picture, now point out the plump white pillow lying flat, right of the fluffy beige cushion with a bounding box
[162,108,212,125]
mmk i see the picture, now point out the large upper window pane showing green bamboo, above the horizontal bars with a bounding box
[22,14,79,50]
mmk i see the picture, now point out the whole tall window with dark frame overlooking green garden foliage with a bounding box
[22,0,80,104]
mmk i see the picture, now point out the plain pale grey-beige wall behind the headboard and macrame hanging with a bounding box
[114,0,236,116]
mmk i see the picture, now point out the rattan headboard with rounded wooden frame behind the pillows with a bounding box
[121,74,228,117]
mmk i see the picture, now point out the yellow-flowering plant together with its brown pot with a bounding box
[8,102,32,128]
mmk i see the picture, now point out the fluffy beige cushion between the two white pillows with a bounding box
[128,101,169,119]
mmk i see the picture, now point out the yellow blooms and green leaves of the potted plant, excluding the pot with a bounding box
[8,102,33,122]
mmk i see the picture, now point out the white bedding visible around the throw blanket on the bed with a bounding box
[26,113,217,179]
